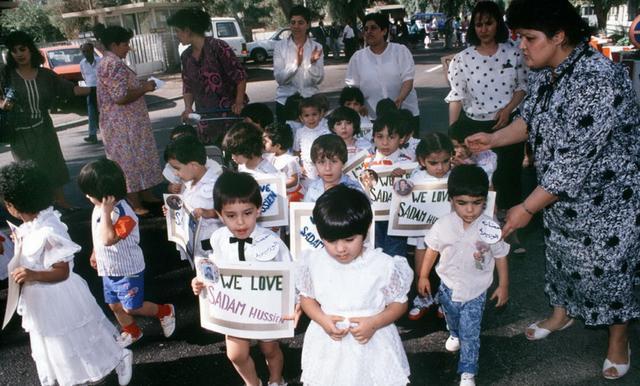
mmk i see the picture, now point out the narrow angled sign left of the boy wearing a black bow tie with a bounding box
[163,194,200,266]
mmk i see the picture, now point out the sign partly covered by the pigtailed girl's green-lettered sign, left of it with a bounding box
[358,162,418,221]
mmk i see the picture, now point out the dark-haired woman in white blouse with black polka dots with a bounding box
[445,1,527,217]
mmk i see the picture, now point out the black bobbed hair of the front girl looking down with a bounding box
[313,184,373,241]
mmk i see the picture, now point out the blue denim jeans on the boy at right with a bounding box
[436,283,487,374]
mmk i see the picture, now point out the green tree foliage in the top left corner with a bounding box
[0,1,63,42]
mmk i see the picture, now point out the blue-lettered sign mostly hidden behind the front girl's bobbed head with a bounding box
[289,202,375,259]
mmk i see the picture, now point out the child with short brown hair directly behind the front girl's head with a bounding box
[304,134,362,202]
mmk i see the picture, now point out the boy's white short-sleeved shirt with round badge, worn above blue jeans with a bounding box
[424,212,509,302]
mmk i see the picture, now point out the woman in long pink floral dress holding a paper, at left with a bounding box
[97,27,162,216]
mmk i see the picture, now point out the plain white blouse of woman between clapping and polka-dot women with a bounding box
[345,43,420,118]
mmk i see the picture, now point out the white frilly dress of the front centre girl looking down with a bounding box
[296,249,413,386]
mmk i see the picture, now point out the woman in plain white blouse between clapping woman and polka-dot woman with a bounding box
[345,13,420,134]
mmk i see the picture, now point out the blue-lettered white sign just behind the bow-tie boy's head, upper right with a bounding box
[253,173,289,228]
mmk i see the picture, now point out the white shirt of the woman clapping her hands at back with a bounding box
[273,37,324,105]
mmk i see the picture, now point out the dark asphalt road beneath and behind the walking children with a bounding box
[0,43,640,386]
